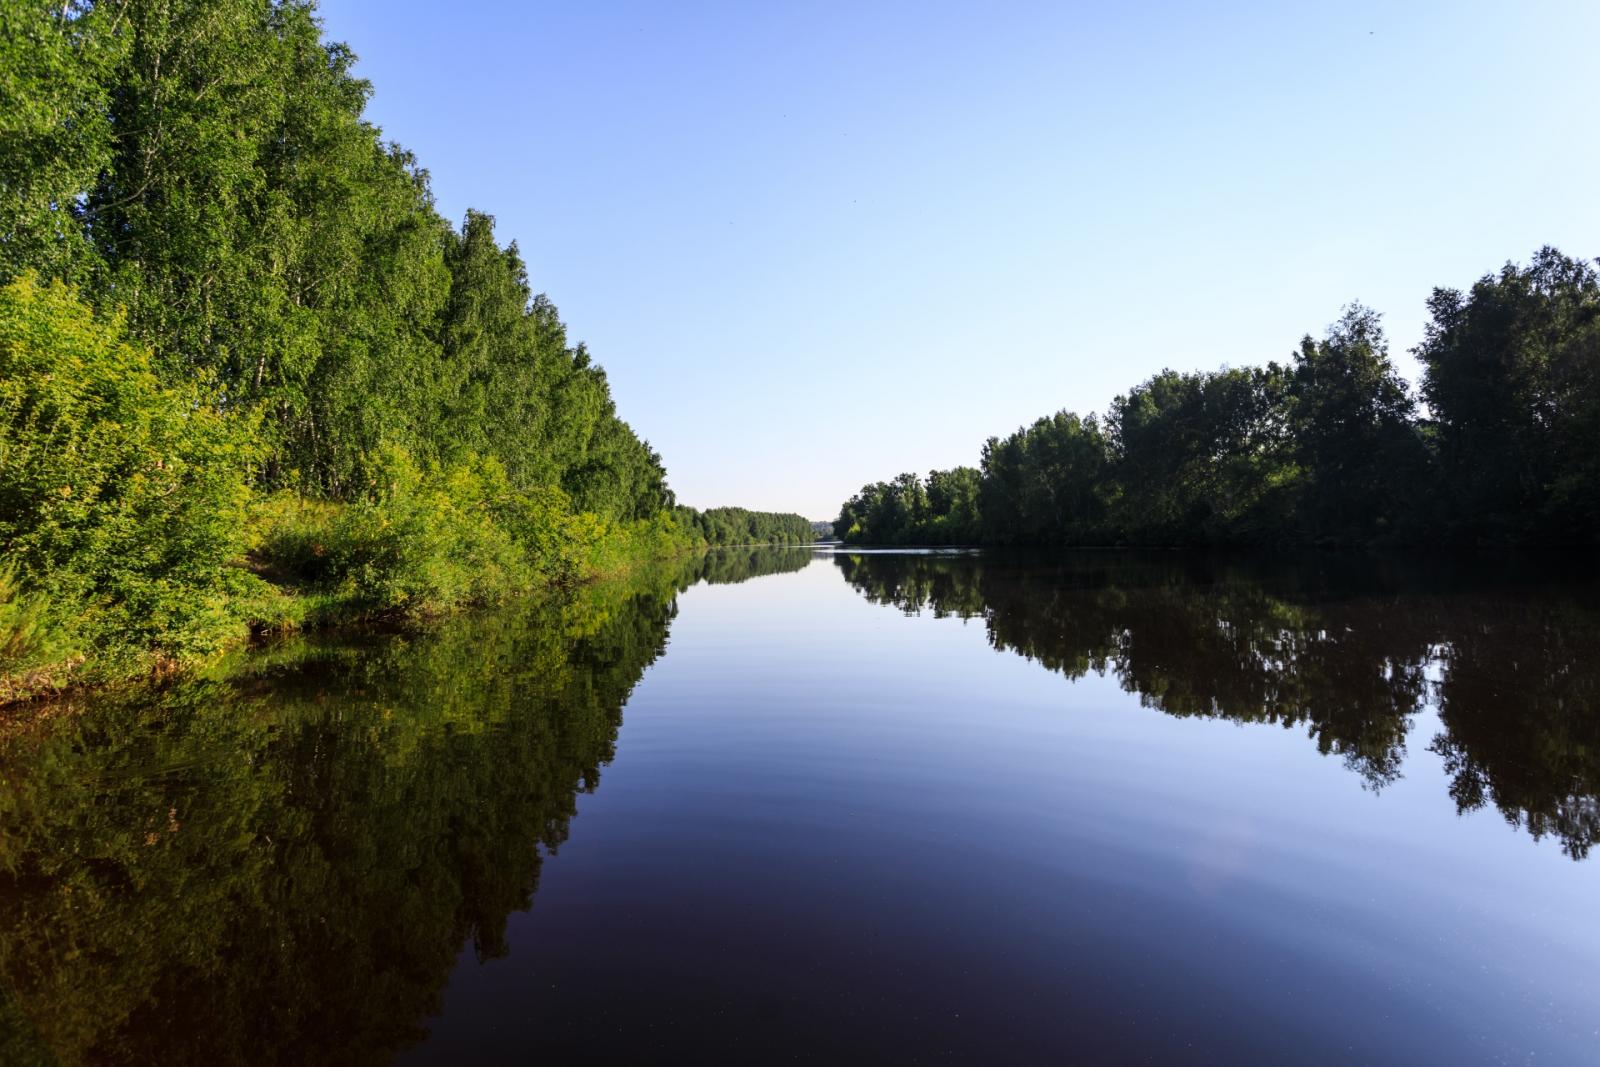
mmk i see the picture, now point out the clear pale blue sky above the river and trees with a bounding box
[323,0,1600,518]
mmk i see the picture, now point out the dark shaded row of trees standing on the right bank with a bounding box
[834,248,1600,547]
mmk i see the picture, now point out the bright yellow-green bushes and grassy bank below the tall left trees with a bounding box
[0,277,811,702]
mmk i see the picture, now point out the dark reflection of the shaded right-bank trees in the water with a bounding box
[835,552,1600,859]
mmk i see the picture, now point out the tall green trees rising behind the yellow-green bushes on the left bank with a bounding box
[0,0,674,522]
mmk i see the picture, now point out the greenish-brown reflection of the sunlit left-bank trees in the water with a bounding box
[0,549,811,1064]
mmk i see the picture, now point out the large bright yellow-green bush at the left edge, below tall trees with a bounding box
[0,277,261,669]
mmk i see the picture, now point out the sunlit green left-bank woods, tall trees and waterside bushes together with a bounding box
[0,0,811,699]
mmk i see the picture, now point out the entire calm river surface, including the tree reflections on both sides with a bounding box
[0,550,1600,1064]
